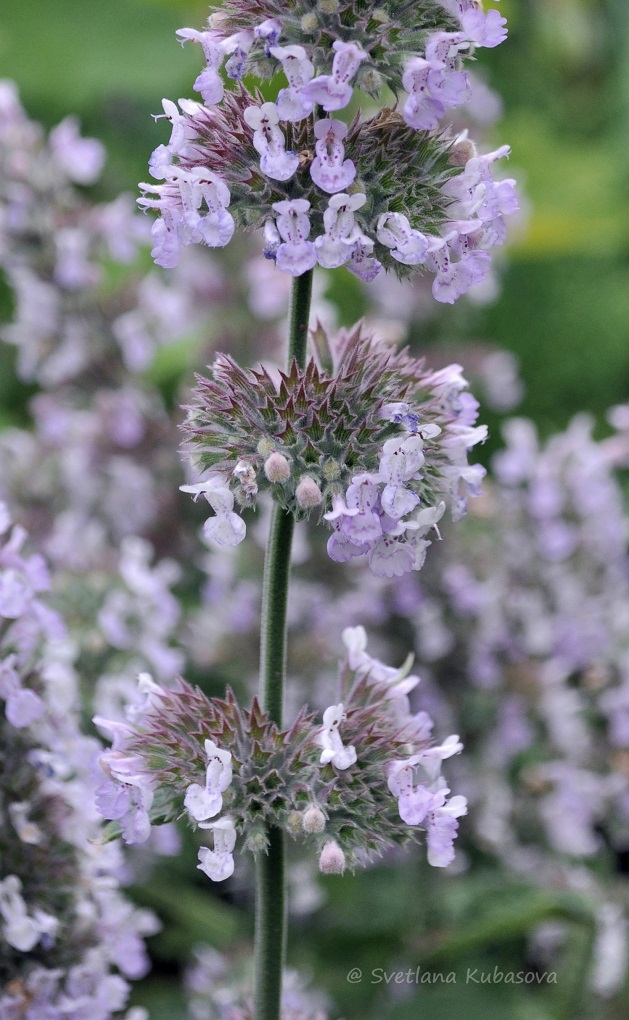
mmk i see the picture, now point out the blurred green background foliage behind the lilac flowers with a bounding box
[0,0,629,1020]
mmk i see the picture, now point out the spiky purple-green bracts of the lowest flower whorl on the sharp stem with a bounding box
[105,652,442,868]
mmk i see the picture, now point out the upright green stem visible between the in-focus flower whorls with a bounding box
[255,270,313,1020]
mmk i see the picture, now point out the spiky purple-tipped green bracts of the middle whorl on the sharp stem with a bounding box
[182,325,456,516]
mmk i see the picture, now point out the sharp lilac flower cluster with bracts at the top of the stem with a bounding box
[139,0,518,303]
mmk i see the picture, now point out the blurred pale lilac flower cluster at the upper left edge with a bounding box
[0,81,146,384]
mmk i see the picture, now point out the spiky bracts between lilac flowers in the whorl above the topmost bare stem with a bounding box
[171,92,462,276]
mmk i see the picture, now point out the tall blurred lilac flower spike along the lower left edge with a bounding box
[0,503,158,1020]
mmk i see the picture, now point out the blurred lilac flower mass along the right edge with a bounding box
[438,416,629,857]
